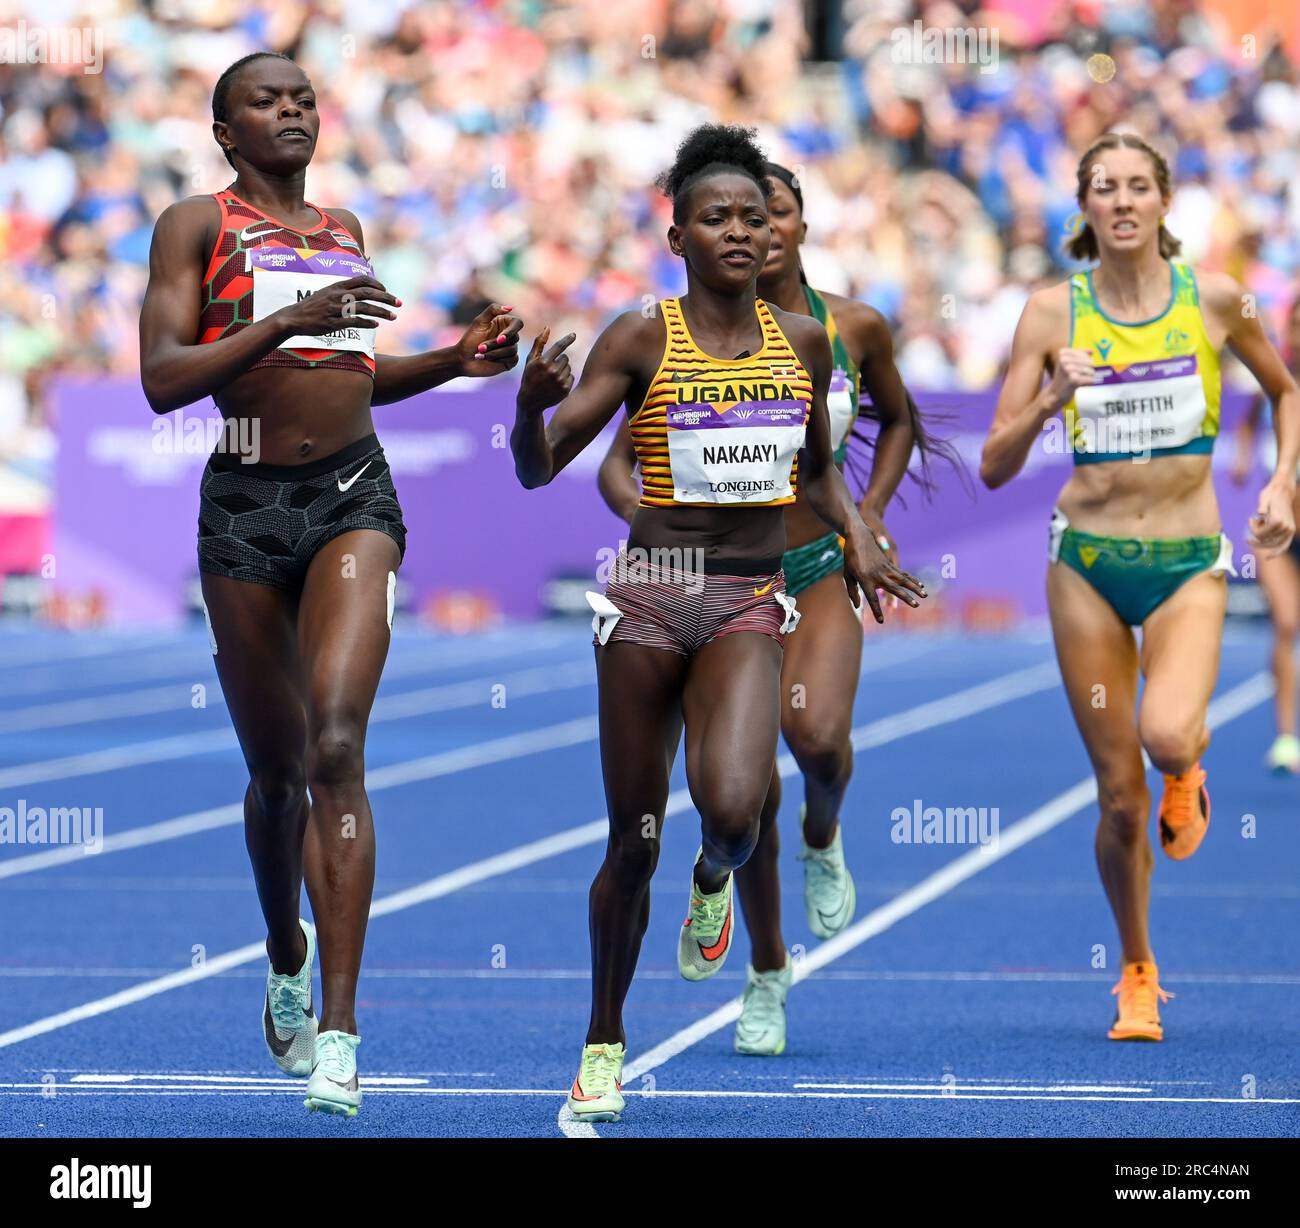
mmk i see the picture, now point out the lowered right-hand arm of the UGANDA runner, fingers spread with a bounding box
[781,316,926,622]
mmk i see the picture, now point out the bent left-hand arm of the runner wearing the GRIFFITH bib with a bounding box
[979,286,1099,490]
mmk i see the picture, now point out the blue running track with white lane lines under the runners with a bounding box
[0,624,1300,1140]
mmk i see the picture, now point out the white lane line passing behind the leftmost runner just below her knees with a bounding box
[0,716,599,878]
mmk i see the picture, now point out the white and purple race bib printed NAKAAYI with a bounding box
[667,400,807,503]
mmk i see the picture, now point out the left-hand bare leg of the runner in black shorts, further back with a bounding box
[202,573,307,975]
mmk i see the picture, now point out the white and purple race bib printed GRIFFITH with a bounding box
[1074,353,1206,454]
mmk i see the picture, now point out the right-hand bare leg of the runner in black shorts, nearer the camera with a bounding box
[298,529,399,1034]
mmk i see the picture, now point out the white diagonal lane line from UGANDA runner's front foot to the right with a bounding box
[603,673,1273,1127]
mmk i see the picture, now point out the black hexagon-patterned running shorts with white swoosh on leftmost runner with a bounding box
[199,435,406,593]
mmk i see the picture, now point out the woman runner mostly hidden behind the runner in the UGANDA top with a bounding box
[599,162,935,1055]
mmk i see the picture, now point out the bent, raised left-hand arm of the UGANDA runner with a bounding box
[510,312,645,490]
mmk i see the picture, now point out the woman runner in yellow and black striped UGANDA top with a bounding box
[511,125,924,1121]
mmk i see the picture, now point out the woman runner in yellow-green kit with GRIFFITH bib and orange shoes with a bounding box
[980,133,1300,1041]
